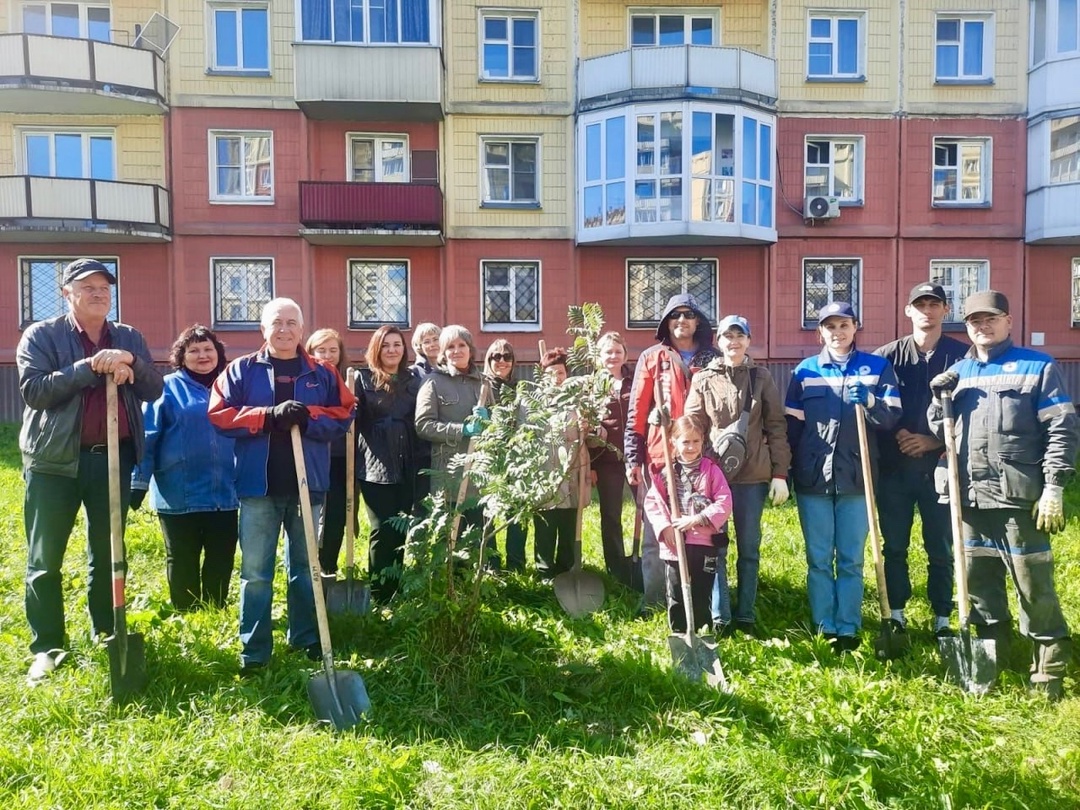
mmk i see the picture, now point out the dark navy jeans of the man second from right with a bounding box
[877,469,953,616]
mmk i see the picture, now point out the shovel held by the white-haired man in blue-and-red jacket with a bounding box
[289,424,372,731]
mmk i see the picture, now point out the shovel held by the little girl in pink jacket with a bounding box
[653,376,728,691]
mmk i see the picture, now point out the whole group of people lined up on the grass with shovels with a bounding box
[17,259,1078,697]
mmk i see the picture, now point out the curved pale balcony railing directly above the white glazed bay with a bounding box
[578,45,777,111]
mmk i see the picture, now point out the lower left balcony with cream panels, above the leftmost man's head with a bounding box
[0,175,171,242]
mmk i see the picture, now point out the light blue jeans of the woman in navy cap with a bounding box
[796,492,869,636]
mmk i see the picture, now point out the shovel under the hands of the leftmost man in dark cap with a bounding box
[105,375,147,703]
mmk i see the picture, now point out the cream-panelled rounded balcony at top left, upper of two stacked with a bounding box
[0,33,166,116]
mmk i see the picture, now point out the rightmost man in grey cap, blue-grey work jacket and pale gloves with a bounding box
[929,289,1080,700]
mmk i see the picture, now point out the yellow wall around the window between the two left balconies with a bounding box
[0,114,165,186]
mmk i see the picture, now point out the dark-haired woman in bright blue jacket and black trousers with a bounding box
[131,324,239,610]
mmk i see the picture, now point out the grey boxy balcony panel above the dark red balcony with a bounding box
[293,42,443,121]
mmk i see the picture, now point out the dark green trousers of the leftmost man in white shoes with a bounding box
[23,442,135,652]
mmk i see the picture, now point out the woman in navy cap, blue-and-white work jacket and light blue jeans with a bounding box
[785,301,901,652]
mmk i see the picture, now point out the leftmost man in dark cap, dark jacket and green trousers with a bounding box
[16,259,163,684]
